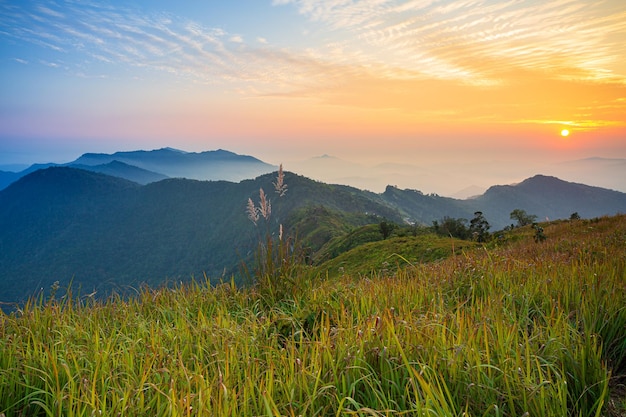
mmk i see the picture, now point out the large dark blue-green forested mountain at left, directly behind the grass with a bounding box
[0,167,401,302]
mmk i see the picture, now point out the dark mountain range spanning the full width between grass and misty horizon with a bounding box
[0,158,626,303]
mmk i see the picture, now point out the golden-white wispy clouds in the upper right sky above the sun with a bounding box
[274,0,626,84]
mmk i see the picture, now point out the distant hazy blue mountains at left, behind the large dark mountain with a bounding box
[0,148,276,190]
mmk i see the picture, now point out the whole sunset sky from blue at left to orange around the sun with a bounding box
[0,0,626,193]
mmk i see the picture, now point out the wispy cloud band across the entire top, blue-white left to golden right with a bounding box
[6,0,626,86]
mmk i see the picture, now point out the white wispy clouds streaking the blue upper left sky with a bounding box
[0,2,336,93]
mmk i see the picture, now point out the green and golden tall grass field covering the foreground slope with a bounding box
[0,216,626,417]
